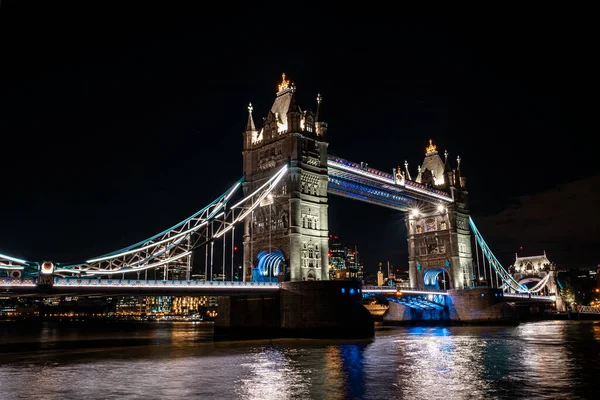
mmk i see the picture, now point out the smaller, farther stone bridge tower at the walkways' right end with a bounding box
[399,140,473,289]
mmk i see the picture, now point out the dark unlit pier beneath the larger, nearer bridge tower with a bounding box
[214,281,374,340]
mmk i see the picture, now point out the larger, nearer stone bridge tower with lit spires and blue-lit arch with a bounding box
[242,74,329,282]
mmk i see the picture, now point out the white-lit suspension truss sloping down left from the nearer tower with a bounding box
[54,164,288,276]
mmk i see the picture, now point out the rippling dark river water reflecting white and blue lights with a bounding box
[0,321,600,400]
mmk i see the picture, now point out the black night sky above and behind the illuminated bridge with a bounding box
[0,1,600,271]
